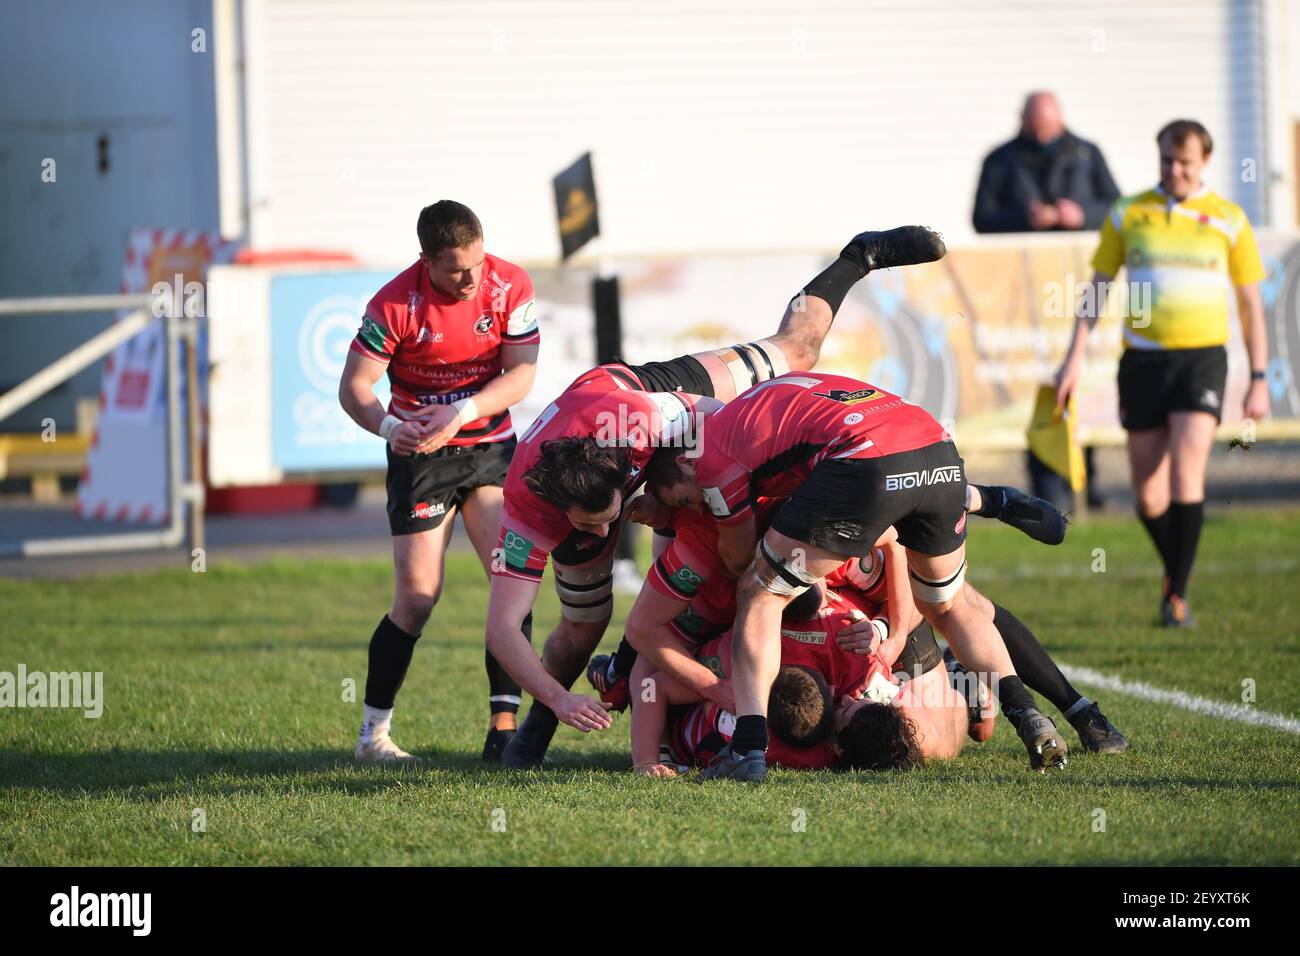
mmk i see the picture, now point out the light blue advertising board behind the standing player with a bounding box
[270,272,393,472]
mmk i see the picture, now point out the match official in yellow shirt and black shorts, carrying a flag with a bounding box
[1056,120,1269,627]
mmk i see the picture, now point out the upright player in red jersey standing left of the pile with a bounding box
[339,199,540,761]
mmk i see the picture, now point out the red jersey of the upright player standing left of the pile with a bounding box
[352,255,541,445]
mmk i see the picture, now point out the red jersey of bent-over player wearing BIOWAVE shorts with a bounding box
[696,372,946,524]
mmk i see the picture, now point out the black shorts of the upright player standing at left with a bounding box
[385,438,515,537]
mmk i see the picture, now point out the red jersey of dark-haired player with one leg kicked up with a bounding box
[493,365,701,580]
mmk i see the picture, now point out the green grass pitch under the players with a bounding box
[0,511,1300,865]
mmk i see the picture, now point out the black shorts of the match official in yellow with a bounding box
[1119,345,1227,432]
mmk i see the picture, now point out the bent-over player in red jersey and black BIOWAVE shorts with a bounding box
[654,372,1067,782]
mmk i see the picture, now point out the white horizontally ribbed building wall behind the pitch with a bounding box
[246,0,1268,261]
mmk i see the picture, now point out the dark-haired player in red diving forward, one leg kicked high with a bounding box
[486,226,945,767]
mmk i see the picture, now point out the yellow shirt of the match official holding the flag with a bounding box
[1092,186,1265,349]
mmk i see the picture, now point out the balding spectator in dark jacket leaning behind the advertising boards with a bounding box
[974,92,1119,233]
